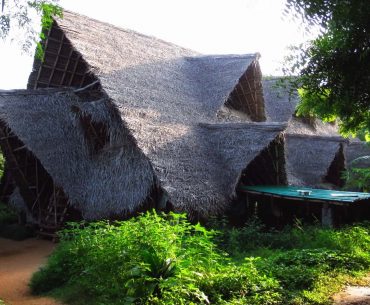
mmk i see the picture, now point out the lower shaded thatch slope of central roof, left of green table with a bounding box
[155,123,285,215]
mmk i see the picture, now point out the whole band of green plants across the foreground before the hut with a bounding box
[30,212,370,305]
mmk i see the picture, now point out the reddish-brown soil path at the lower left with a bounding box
[0,238,62,305]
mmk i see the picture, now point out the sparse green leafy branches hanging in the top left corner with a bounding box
[0,0,62,51]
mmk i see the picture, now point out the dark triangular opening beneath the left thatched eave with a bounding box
[0,121,80,235]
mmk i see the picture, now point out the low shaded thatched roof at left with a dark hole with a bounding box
[0,90,154,219]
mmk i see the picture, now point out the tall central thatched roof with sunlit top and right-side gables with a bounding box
[24,12,284,215]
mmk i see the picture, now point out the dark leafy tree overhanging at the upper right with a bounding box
[286,0,370,137]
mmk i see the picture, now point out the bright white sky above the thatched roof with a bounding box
[0,0,314,89]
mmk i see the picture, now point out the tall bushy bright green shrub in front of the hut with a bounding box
[31,212,280,305]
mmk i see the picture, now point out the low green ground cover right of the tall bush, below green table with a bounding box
[212,220,370,304]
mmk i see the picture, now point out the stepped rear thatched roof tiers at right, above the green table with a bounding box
[263,79,346,187]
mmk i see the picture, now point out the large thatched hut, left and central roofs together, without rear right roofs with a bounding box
[0,12,286,227]
